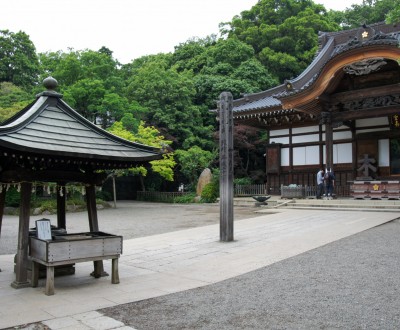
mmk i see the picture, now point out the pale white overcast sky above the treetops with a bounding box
[0,0,362,64]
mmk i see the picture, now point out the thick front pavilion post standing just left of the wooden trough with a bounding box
[11,182,32,289]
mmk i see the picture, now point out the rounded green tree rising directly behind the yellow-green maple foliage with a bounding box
[127,57,212,148]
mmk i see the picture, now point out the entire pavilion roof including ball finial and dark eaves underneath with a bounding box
[0,78,161,179]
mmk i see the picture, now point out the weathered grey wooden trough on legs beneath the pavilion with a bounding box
[29,232,122,296]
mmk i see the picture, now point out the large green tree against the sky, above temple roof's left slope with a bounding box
[221,0,340,82]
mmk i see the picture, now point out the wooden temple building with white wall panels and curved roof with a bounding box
[233,23,400,198]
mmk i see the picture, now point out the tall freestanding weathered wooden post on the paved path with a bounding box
[218,92,233,242]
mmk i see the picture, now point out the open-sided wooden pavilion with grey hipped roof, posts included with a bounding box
[0,77,161,288]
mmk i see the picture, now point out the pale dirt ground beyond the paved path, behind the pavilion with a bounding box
[0,201,259,254]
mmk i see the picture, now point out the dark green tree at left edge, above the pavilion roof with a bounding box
[0,30,39,88]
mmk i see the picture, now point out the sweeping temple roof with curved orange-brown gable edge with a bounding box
[233,23,400,126]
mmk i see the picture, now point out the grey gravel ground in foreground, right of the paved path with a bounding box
[100,220,400,330]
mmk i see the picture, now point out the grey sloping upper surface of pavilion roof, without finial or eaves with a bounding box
[0,82,161,167]
